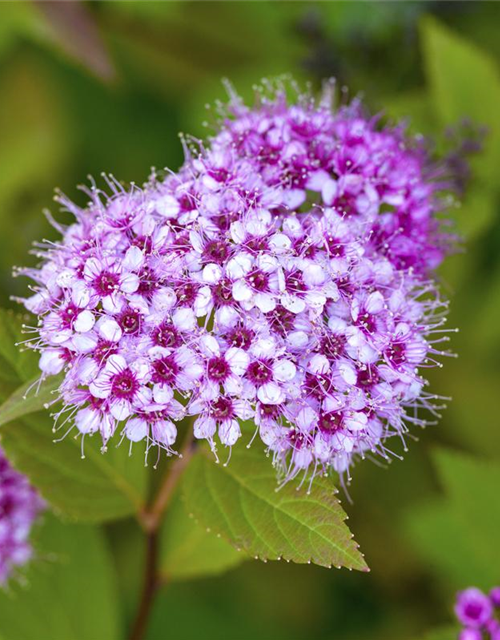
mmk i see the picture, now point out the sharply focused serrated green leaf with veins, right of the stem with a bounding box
[183,446,368,571]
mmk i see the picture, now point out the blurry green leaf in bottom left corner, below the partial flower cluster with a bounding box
[0,516,121,640]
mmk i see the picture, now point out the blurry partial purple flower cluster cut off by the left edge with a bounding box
[0,449,44,587]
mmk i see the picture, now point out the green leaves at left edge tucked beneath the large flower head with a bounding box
[0,310,147,522]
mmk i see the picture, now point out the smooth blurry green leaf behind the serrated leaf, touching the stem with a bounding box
[160,494,248,581]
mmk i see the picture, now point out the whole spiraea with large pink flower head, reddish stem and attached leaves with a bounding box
[1,82,472,638]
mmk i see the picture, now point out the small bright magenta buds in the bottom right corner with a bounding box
[455,587,500,640]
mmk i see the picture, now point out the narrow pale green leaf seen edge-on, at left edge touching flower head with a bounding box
[0,374,63,426]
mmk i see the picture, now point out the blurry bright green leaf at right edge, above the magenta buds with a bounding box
[408,450,500,589]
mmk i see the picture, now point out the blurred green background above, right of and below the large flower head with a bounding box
[0,0,500,640]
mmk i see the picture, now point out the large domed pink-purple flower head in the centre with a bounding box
[19,80,458,478]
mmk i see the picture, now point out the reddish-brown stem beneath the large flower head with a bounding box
[129,429,193,640]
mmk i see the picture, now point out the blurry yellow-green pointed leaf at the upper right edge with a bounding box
[422,17,500,185]
